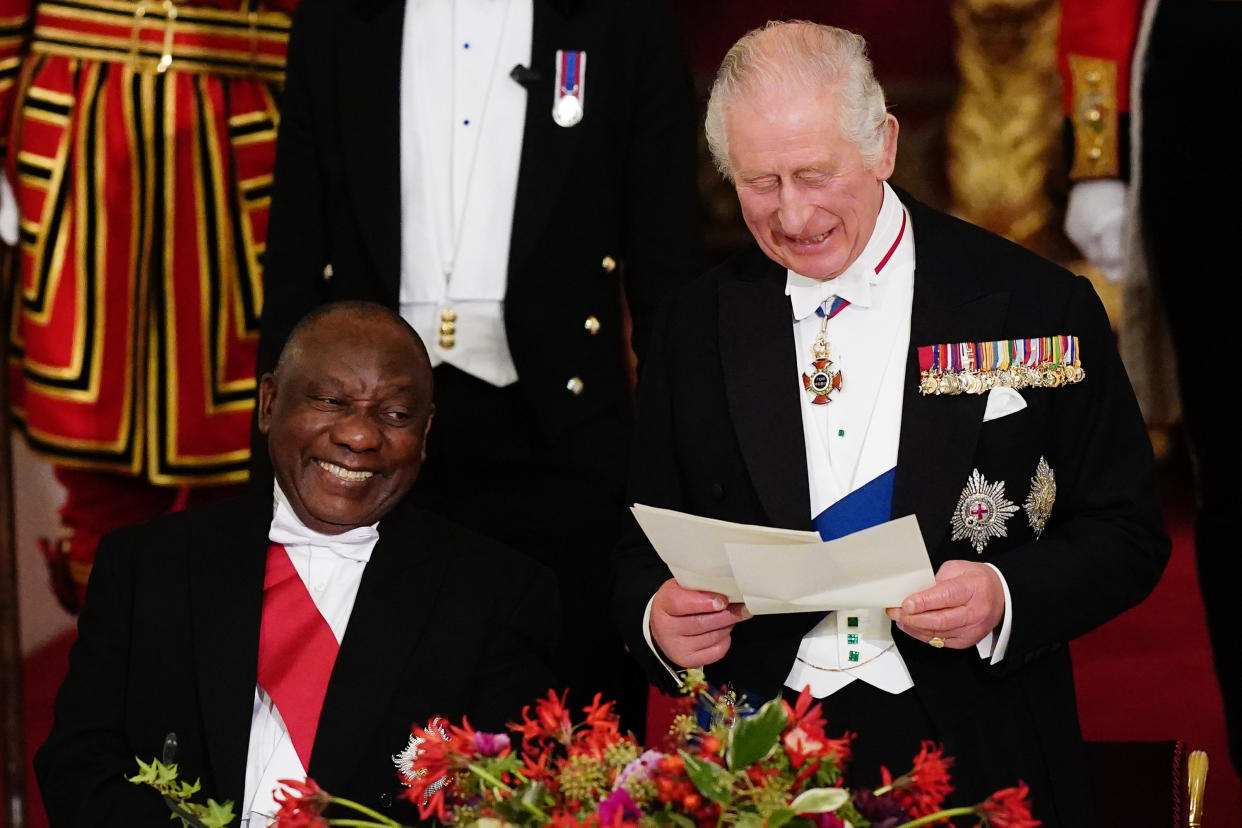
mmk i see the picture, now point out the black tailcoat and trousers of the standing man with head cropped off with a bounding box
[257,0,698,727]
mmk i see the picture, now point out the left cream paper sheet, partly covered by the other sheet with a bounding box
[631,503,821,602]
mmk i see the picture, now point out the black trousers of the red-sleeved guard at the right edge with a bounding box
[1140,0,1242,771]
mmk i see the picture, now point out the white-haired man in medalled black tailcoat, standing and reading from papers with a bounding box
[615,22,1169,826]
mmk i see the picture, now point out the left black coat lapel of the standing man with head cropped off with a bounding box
[335,0,405,288]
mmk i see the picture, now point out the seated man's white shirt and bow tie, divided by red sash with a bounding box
[241,483,380,828]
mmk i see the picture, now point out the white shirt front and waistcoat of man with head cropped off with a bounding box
[400,0,533,386]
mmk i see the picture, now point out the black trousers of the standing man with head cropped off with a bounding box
[412,364,647,735]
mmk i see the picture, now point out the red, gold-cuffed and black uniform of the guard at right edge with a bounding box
[1058,0,1242,772]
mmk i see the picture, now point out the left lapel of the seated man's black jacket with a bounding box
[189,493,272,802]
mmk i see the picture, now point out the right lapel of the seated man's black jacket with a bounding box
[309,504,445,790]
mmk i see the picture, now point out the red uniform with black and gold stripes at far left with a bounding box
[0,0,297,606]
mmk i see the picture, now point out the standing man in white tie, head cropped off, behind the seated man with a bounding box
[256,0,699,731]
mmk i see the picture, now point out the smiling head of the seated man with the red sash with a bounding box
[258,310,431,534]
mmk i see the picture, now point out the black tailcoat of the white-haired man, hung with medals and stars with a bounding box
[615,195,1169,826]
